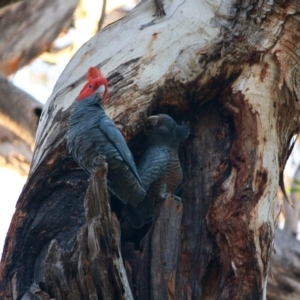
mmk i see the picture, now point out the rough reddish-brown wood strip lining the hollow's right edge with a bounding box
[207,91,270,299]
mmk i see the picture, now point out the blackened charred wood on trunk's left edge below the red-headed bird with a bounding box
[0,146,88,299]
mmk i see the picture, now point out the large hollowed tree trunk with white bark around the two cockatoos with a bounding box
[0,0,300,300]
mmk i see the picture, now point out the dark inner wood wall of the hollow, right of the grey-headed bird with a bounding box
[175,99,235,299]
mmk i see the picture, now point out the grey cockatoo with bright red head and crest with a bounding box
[67,68,146,207]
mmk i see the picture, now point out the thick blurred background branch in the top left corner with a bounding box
[0,0,78,75]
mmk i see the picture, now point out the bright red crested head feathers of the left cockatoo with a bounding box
[77,67,109,104]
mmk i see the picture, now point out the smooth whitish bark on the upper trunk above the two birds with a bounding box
[32,1,220,171]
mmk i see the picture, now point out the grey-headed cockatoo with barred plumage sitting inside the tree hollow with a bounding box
[121,114,190,241]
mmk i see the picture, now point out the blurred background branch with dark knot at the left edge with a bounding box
[0,76,43,175]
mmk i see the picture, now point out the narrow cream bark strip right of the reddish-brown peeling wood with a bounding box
[231,55,288,299]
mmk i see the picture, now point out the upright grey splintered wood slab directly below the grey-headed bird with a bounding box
[138,195,183,300]
